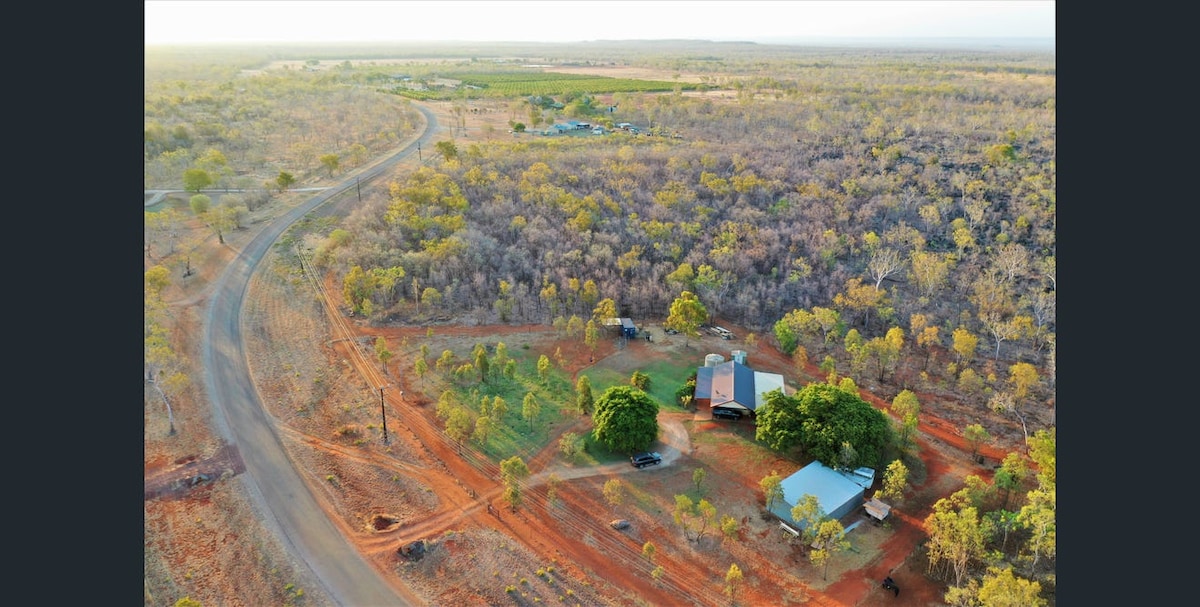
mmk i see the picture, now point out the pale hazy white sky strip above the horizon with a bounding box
[144,0,1055,44]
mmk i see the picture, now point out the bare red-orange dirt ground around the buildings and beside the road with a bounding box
[145,97,1010,607]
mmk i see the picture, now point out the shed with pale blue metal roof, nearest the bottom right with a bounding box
[770,462,875,529]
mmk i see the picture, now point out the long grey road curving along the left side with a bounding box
[202,106,438,607]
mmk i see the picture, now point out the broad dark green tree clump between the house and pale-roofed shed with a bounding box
[755,383,894,468]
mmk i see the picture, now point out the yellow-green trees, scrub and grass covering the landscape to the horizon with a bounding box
[144,38,1057,606]
